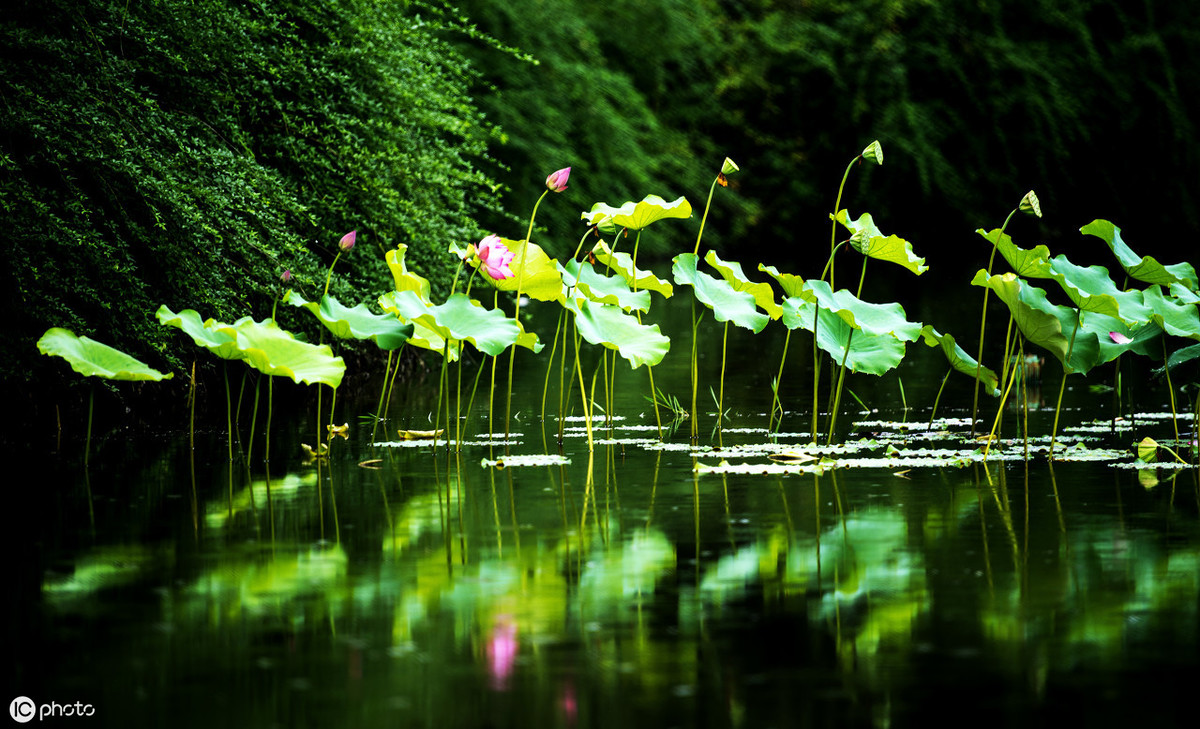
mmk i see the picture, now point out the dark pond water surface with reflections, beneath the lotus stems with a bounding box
[8,293,1200,728]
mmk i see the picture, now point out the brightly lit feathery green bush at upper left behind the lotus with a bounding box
[0,0,497,393]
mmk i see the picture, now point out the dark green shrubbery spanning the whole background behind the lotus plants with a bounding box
[0,0,1200,410]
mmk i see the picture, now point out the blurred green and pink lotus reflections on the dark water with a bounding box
[18,410,1200,727]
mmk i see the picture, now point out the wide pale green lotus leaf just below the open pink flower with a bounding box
[380,291,542,356]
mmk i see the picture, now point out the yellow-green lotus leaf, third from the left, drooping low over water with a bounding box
[208,317,346,387]
